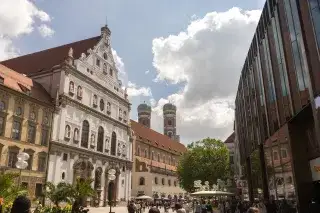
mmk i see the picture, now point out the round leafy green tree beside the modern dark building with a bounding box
[177,138,230,192]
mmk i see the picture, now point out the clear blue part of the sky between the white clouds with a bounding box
[0,0,264,143]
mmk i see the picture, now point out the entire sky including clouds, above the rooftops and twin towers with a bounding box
[0,0,265,144]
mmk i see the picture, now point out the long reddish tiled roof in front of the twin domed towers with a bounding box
[131,120,187,155]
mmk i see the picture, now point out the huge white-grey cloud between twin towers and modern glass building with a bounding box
[151,8,261,142]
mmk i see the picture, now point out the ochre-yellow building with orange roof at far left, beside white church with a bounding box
[0,65,53,198]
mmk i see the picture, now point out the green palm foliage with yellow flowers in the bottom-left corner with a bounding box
[0,173,27,211]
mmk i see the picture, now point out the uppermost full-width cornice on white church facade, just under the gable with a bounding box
[63,64,131,106]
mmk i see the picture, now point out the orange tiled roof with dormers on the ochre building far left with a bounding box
[0,64,52,104]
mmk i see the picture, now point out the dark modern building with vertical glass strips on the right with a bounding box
[235,0,320,212]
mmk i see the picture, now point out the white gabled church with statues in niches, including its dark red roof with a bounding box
[2,26,132,206]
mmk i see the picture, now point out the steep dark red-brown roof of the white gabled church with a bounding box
[0,36,101,75]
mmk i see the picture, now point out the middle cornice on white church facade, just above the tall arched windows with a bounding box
[59,95,130,131]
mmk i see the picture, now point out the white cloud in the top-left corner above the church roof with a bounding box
[0,0,51,60]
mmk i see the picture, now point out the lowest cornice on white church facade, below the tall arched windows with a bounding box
[49,141,133,165]
